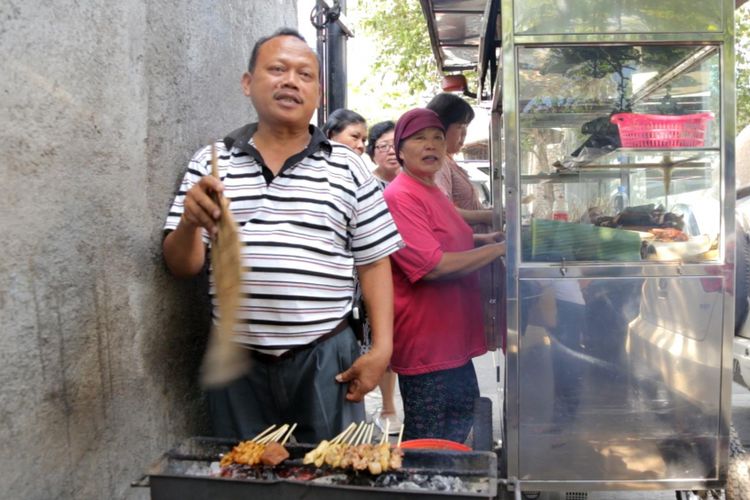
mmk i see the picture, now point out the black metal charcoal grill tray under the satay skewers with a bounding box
[142,437,497,500]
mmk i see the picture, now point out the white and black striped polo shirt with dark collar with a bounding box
[164,124,404,355]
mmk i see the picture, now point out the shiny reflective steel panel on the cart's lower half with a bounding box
[518,277,724,481]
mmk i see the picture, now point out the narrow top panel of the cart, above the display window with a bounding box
[513,0,722,35]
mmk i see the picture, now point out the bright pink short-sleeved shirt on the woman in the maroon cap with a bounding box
[384,174,487,375]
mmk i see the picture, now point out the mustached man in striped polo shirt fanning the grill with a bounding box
[163,29,403,442]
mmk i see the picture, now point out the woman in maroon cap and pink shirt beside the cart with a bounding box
[385,109,505,442]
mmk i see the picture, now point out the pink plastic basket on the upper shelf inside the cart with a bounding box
[611,113,714,149]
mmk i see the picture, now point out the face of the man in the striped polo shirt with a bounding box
[242,36,320,126]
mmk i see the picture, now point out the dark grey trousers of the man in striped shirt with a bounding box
[207,328,365,443]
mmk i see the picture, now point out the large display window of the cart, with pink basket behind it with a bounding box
[518,46,721,262]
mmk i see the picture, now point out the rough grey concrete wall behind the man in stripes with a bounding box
[0,0,297,499]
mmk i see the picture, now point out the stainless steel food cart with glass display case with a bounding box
[422,0,735,498]
